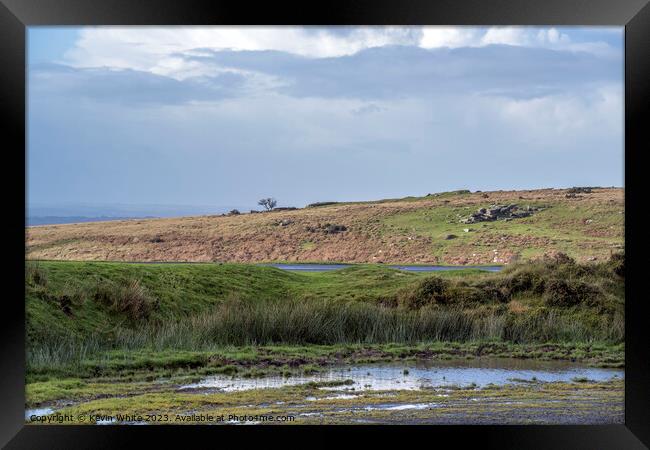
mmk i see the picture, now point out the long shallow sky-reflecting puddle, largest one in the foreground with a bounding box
[180,358,624,394]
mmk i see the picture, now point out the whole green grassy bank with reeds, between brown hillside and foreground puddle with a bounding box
[26,256,624,372]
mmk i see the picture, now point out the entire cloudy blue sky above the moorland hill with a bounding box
[27,26,624,215]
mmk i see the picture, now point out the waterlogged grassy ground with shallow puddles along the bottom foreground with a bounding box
[25,357,625,425]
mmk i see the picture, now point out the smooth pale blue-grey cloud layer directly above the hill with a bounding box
[28,80,622,205]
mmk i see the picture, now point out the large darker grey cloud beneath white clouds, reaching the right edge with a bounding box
[181,45,623,99]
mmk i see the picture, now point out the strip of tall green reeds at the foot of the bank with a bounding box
[116,301,624,349]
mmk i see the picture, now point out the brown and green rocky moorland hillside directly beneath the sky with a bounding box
[27,188,624,264]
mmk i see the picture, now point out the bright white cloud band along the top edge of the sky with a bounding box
[60,26,622,79]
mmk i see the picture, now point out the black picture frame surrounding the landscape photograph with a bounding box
[0,0,650,449]
